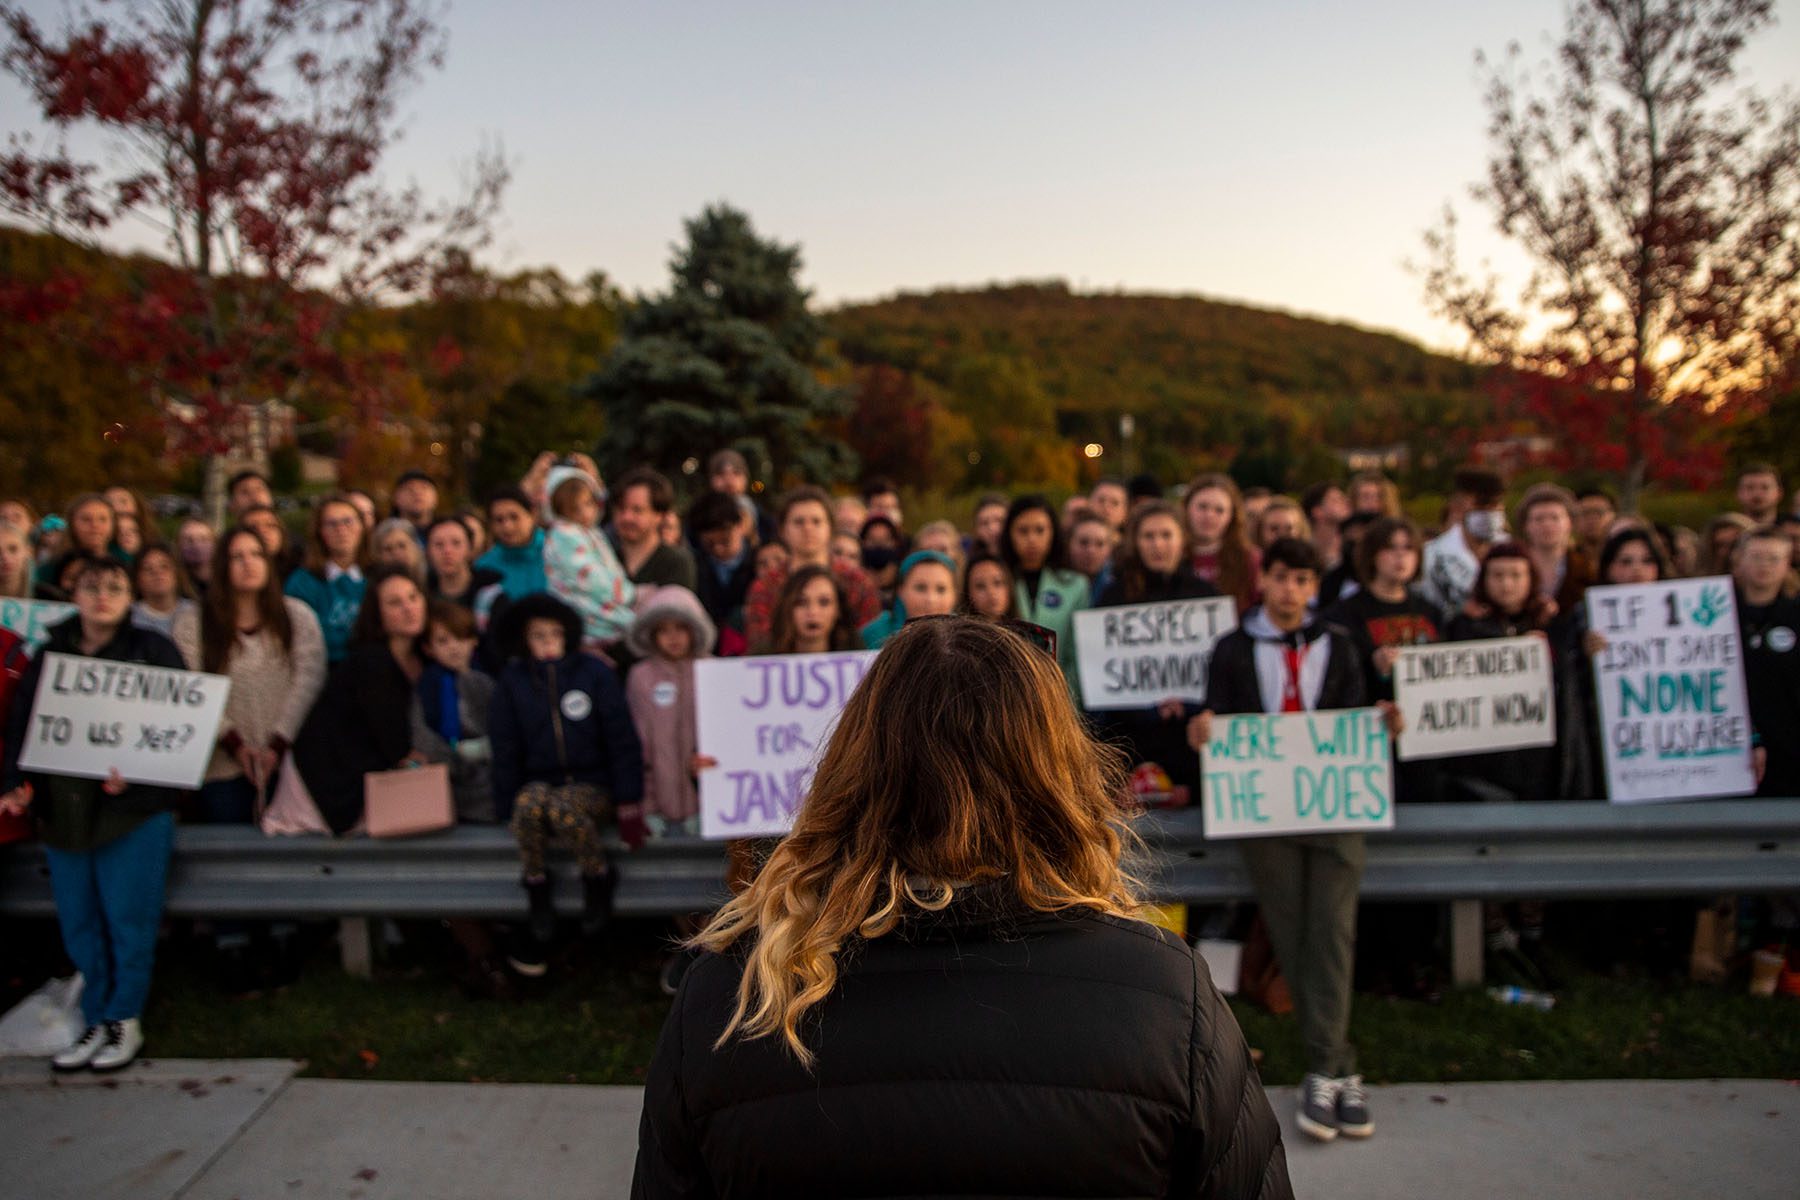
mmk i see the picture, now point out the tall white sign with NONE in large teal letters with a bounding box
[1588,576,1756,804]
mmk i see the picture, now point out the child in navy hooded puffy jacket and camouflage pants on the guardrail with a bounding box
[488,596,644,946]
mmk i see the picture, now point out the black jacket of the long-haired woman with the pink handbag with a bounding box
[293,642,414,833]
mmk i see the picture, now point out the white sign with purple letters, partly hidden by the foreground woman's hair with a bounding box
[693,649,875,838]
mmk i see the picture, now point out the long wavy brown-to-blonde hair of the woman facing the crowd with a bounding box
[693,617,1138,1067]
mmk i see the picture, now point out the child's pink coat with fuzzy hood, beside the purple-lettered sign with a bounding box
[625,587,716,822]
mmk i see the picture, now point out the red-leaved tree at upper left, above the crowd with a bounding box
[0,0,508,492]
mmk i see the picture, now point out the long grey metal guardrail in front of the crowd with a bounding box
[0,799,1800,981]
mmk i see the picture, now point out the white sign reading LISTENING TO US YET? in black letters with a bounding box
[18,653,230,788]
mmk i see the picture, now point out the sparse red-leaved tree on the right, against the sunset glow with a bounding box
[1424,0,1800,506]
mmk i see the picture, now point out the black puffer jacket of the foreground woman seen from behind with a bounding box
[632,901,1292,1200]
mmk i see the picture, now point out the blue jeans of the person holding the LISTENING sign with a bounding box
[43,813,175,1025]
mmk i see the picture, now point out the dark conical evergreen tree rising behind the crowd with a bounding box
[583,205,857,484]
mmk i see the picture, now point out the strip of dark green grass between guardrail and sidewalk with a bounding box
[5,921,1800,1085]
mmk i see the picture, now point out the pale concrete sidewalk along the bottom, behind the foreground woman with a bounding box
[0,1060,1800,1200]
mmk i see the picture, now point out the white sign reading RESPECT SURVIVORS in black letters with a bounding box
[1075,596,1237,712]
